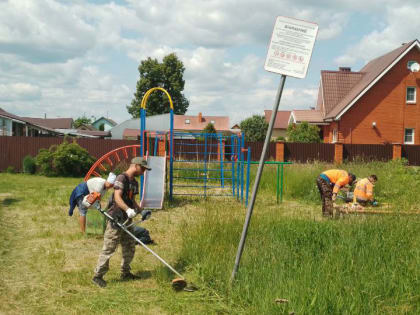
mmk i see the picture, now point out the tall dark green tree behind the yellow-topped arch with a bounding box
[127,53,189,118]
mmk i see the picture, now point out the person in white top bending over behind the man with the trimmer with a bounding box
[69,173,116,233]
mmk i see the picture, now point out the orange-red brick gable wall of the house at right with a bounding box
[336,48,420,144]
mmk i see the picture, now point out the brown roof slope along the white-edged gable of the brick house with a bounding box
[324,40,419,118]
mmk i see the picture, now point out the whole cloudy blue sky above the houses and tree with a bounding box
[0,0,420,125]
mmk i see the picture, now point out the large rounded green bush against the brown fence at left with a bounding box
[36,139,94,177]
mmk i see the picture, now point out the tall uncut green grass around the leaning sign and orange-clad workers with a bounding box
[180,161,420,314]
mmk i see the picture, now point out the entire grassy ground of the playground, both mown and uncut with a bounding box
[0,162,420,314]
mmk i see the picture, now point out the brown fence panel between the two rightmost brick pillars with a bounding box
[343,144,392,162]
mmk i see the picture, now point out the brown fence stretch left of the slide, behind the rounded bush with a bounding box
[0,136,139,171]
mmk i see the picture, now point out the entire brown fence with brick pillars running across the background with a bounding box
[4,136,420,171]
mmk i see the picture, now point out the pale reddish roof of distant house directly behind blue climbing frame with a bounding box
[174,115,230,131]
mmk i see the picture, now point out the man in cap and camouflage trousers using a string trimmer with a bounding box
[92,157,151,287]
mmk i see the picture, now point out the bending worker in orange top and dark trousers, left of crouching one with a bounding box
[316,170,356,216]
